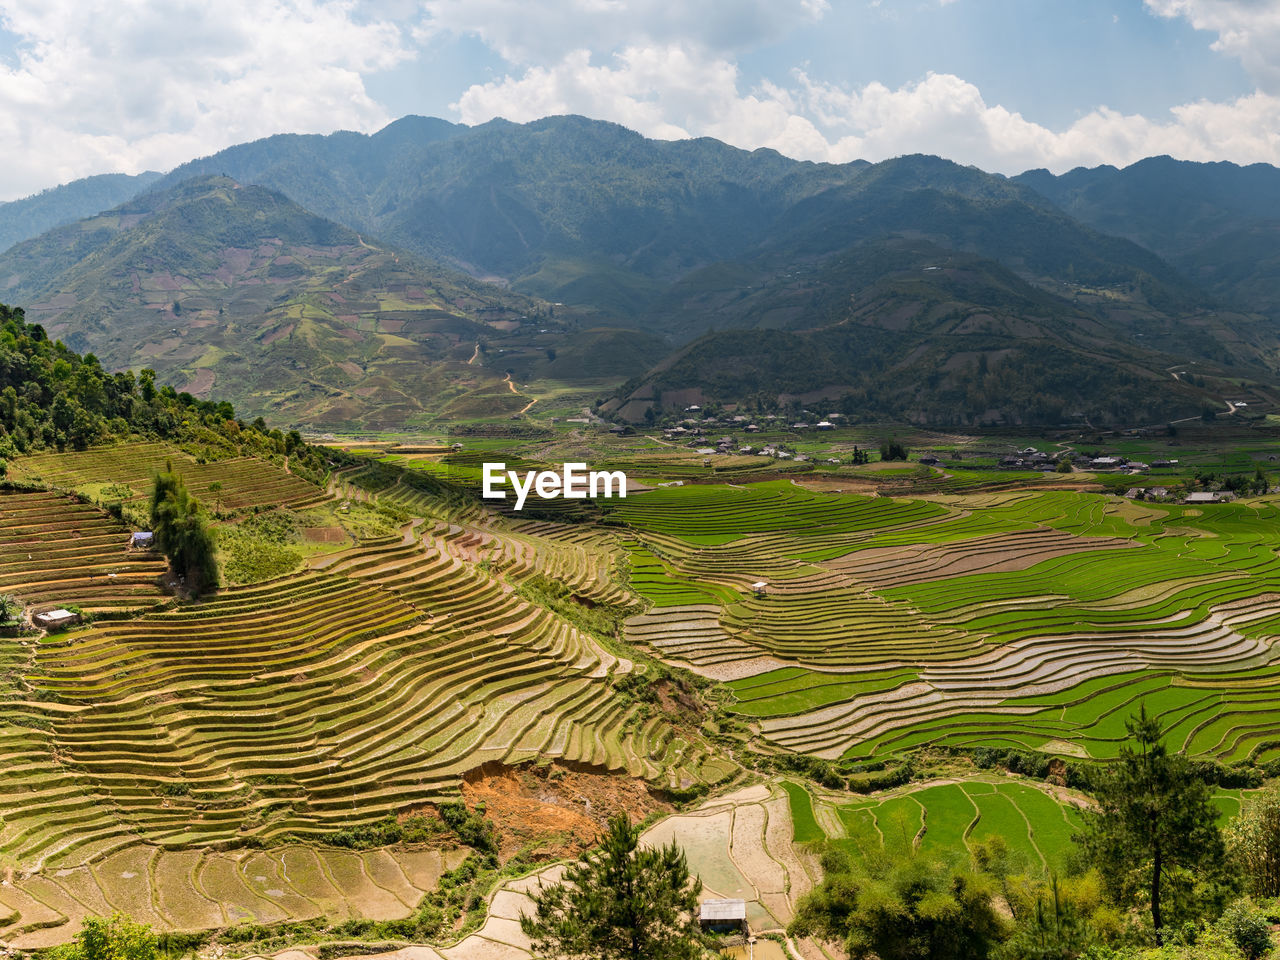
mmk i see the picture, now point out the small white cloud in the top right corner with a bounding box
[1143,0,1280,93]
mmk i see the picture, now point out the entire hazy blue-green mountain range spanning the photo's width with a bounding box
[0,116,1280,429]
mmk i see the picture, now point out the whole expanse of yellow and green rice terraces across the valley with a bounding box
[0,443,1280,957]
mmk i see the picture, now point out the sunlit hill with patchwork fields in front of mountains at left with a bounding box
[0,178,655,429]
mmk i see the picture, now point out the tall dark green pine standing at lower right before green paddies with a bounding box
[1083,707,1225,943]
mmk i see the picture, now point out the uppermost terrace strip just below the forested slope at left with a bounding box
[13,443,325,511]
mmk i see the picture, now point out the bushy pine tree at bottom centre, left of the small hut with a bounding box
[520,814,704,960]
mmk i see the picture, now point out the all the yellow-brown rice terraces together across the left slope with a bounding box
[0,444,736,946]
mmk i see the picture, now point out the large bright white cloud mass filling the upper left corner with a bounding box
[0,0,410,197]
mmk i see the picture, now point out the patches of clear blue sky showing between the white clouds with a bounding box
[370,0,1254,127]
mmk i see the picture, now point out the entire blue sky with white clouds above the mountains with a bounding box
[0,0,1280,198]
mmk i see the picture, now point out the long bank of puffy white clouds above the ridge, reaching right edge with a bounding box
[454,45,1280,174]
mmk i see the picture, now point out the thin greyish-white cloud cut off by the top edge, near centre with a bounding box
[419,0,828,67]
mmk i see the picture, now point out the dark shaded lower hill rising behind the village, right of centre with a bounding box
[611,239,1267,424]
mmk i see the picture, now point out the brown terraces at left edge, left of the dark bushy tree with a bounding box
[0,490,165,616]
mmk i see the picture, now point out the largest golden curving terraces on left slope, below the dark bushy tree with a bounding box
[0,535,730,865]
